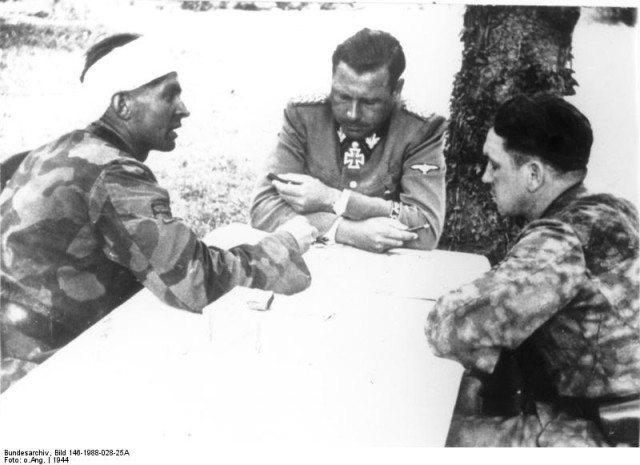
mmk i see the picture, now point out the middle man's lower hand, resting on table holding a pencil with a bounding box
[336,217,418,253]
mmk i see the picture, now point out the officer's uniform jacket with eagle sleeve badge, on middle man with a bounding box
[251,97,445,249]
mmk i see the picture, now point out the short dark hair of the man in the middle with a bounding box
[332,29,406,87]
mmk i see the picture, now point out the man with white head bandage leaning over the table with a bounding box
[0,34,316,390]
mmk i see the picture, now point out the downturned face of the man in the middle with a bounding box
[330,62,402,139]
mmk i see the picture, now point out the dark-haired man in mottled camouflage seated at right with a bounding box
[426,96,640,446]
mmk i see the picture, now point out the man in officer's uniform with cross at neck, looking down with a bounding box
[251,29,445,252]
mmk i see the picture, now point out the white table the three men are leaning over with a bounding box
[0,225,489,453]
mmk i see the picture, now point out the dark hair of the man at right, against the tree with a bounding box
[493,94,593,173]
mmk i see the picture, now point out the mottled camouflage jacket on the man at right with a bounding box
[426,185,640,398]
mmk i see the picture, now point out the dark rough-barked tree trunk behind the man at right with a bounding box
[439,6,580,264]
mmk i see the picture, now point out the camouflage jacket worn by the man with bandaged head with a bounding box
[0,123,310,358]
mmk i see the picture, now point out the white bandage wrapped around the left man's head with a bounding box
[82,35,177,109]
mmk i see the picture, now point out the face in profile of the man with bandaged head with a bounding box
[131,73,189,152]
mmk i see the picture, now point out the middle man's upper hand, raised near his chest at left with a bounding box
[271,173,340,214]
